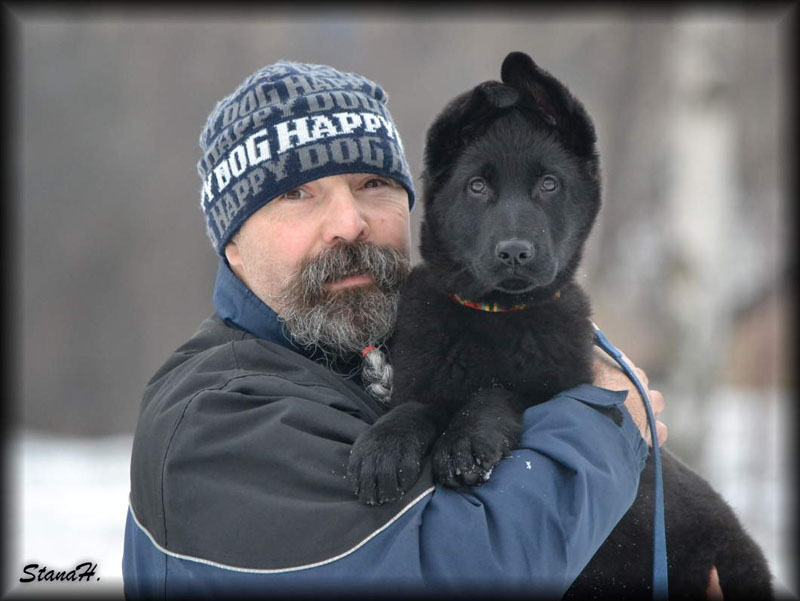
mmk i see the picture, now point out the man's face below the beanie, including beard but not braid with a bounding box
[225,173,410,354]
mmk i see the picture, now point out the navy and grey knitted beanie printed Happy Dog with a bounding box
[197,61,414,256]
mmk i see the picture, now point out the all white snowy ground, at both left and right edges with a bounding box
[3,390,797,599]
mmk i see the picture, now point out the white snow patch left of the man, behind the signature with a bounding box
[4,432,133,598]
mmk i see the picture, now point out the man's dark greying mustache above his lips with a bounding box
[290,242,410,304]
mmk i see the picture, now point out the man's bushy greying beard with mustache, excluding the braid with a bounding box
[280,242,410,359]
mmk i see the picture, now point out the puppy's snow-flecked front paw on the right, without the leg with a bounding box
[433,429,511,488]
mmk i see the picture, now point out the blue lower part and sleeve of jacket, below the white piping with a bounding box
[123,385,648,598]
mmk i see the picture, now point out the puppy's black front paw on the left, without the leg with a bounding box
[347,424,425,505]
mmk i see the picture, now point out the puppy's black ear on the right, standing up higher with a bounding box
[500,52,597,156]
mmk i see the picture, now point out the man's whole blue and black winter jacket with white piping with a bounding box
[123,260,647,599]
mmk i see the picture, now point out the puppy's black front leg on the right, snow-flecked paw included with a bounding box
[433,388,525,488]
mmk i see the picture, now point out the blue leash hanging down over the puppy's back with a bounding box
[594,326,669,601]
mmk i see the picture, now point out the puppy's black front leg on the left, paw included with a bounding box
[347,401,444,505]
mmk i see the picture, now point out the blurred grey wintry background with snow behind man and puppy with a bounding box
[0,3,797,596]
